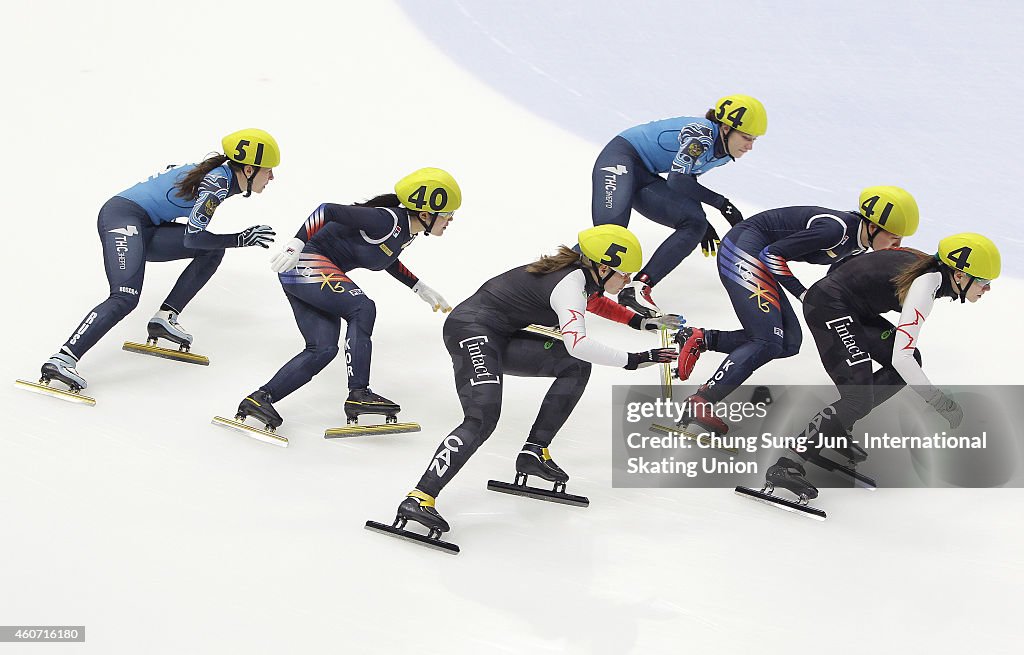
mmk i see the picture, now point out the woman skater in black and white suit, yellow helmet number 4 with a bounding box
[745,232,1000,513]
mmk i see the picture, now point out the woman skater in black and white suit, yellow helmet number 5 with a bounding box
[387,225,679,537]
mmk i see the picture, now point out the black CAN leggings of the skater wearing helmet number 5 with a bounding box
[416,317,591,496]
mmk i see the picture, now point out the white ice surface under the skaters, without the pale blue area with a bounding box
[0,0,1024,655]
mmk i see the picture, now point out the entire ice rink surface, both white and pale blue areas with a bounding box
[0,0,1024,655]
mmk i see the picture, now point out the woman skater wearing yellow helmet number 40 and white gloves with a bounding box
[237,168,462,430]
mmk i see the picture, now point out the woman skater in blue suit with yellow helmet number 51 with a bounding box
[42,129,281,391]
